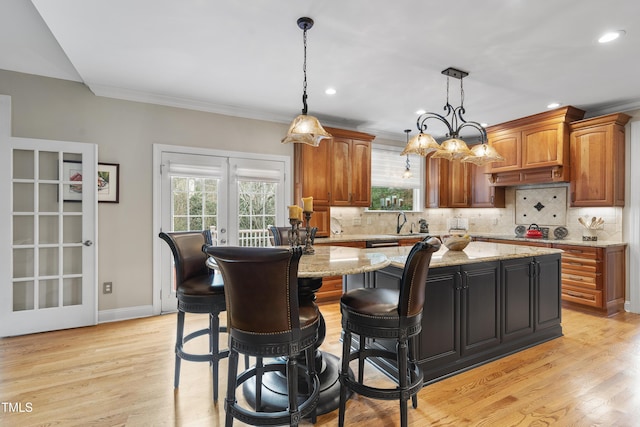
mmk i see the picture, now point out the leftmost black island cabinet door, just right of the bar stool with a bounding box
[418,267,462,366]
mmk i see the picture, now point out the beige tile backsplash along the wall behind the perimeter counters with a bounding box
[331,184,624,241]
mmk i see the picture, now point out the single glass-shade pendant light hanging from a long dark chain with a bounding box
[282,17,331,147]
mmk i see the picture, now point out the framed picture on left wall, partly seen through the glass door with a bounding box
[62,160,120,203]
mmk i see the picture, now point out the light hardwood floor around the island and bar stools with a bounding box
[0,304,640,427]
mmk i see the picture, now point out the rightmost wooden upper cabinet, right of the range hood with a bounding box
[570,113,630,207]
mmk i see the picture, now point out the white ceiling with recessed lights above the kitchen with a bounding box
[0,0,640,140]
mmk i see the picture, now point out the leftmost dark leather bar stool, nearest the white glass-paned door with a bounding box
[159,231,229,400]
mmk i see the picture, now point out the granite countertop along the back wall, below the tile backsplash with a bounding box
[315,231,626,248]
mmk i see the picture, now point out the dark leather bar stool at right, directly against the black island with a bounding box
[338,237,440,427]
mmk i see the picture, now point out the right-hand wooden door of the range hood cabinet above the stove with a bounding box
[522,123,569,169]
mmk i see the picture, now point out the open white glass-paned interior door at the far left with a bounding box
[0,96,98,336]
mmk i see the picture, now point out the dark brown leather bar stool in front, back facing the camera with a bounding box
[205,246,320,427]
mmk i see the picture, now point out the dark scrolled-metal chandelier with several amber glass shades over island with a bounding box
[401,67,504,166]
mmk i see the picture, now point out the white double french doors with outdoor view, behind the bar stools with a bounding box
[154,147,288,312]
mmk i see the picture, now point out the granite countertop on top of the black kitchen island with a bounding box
[361,242,562,268]
